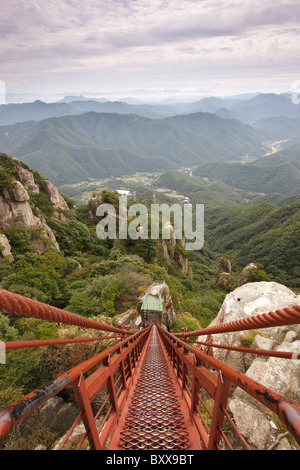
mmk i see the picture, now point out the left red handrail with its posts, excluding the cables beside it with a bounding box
[0,327,151,449]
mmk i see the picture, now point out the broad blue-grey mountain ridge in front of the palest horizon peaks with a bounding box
[0,112,265,185]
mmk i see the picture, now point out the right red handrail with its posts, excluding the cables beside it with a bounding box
[158,327,300,449]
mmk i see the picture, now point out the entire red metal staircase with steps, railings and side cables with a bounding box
[0,290,300,451]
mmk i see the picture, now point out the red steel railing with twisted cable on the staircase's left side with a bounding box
[0,290,151,450]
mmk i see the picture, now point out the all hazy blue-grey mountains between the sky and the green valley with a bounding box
[0,93,300,188]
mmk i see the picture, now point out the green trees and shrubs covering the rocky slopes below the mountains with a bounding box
[0,151,300,444]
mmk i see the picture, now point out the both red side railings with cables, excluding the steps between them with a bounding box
[0,290,300,450]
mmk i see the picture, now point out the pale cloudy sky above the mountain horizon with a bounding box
[0,0,300,101]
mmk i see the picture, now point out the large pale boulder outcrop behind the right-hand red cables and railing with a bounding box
[203,282,300,449]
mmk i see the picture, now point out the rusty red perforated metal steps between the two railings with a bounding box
[119,327,190,450]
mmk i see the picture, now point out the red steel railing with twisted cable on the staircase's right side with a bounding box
[159,306,300,450]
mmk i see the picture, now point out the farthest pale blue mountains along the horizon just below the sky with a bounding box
[0,93,300,126]
